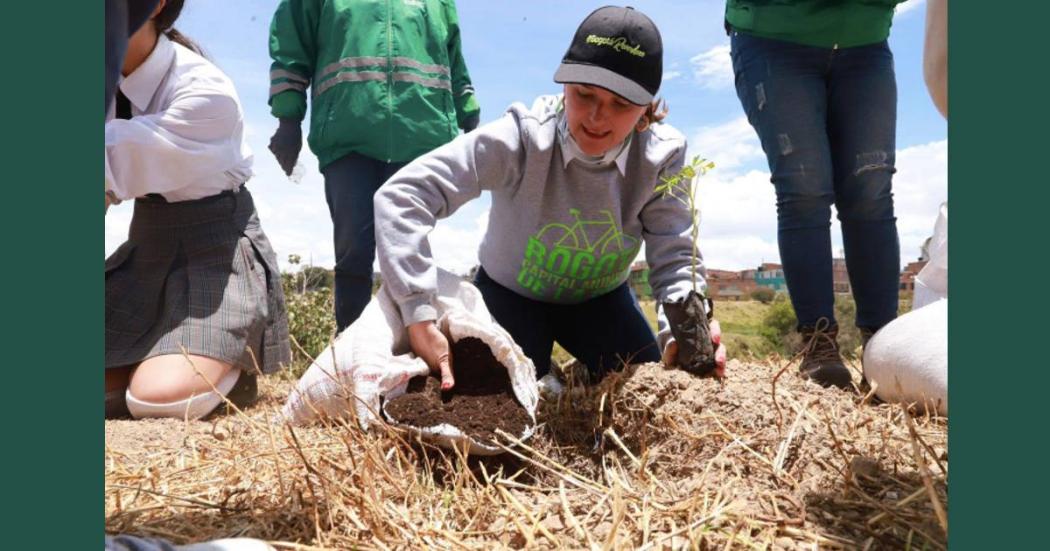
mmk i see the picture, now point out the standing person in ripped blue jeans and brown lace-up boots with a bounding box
[726,0,901,388]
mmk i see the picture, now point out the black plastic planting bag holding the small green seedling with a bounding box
[663,291,717,377]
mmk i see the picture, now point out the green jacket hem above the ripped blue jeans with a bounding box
[726,0,904,48]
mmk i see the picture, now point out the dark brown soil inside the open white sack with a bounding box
[385,337,532,444]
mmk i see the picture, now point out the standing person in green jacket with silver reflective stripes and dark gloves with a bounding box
[270,0,481,331]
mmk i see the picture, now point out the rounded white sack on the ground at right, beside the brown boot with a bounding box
[864,299,948,416]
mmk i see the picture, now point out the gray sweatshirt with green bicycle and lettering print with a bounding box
[375,96,706,349]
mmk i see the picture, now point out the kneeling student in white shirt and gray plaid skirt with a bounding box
[105,0,291,419]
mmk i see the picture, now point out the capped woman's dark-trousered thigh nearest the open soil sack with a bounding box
[476,269,554,378]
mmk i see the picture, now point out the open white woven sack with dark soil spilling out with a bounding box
[282,270,539,454]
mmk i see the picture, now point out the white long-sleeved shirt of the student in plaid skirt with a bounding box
[105,35,252,202]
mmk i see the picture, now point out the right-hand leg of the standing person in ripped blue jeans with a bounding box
[827,42,901,333]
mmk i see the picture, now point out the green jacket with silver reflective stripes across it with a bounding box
[270,0,481,168]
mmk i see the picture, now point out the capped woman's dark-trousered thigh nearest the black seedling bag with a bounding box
[551,283,660,380]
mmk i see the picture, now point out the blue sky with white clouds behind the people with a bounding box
[106,0,947,271]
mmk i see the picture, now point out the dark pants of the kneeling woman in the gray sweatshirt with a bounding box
[474,269,660,378]
